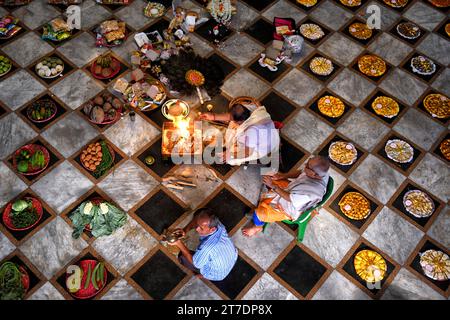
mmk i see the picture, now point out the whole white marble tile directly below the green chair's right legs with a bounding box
[303,209,359,267]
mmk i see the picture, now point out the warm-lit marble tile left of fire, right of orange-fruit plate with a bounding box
[104,114,160,156]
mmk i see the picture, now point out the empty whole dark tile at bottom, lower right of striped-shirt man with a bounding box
[274,246,327,297]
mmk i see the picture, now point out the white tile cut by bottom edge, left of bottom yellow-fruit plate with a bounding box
[312,270,371,300]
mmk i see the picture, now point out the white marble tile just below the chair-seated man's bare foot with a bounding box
[232,220,294,270]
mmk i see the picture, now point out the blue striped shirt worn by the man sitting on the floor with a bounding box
[193,223,238,281]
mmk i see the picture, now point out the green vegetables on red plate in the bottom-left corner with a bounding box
[0,261,25,300]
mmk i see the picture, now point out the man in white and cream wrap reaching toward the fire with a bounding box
[200,103,280,165]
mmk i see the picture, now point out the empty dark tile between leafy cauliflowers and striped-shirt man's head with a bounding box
[136,190,186,234]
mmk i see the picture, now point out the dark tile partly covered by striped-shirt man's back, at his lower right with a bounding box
[211,256,258,299]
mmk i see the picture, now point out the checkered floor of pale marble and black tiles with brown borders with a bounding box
[0,0,450,299]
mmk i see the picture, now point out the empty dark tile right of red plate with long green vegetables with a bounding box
[131,251,186,300]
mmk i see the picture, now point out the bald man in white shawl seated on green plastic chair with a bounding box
[242,156,330,237]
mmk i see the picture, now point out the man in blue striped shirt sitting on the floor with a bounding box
[172,208,238,281]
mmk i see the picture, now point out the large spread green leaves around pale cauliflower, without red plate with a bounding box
[69,201,127,239]
